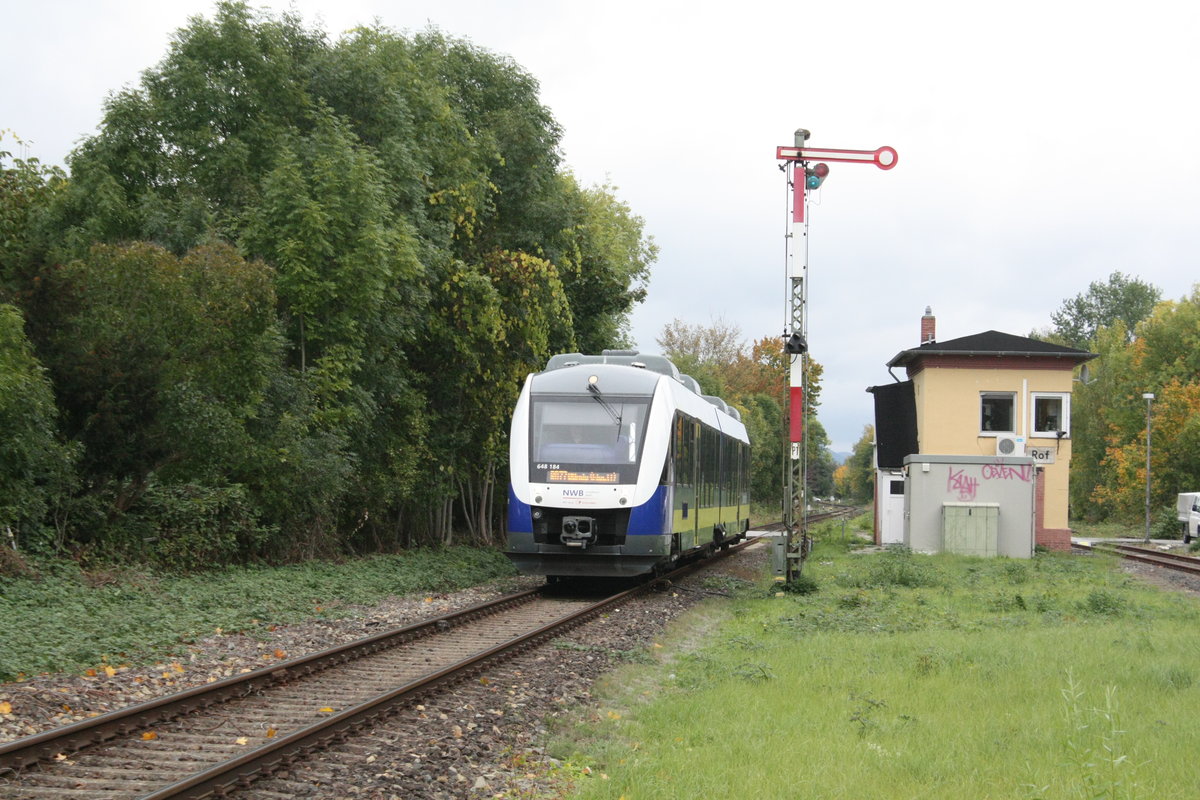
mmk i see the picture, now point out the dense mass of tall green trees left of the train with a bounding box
[0,2,655,566]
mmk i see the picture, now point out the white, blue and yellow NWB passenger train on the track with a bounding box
[505,350,750,581]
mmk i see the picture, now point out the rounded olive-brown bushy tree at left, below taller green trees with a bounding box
[48,243,280,557]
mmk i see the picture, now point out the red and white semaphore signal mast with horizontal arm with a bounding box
[775,128,899,583]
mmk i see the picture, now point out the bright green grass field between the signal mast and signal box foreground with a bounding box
[551,522,1200,800]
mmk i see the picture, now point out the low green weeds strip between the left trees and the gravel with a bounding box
[0,547,515,680]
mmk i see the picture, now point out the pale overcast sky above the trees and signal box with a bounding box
[0,0,1200,451]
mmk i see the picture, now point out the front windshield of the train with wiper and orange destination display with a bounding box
[529,396,650,483]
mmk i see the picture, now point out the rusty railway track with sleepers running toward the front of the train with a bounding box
[0,542,751,800]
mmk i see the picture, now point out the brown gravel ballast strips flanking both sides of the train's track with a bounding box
[0,545,767,800]
